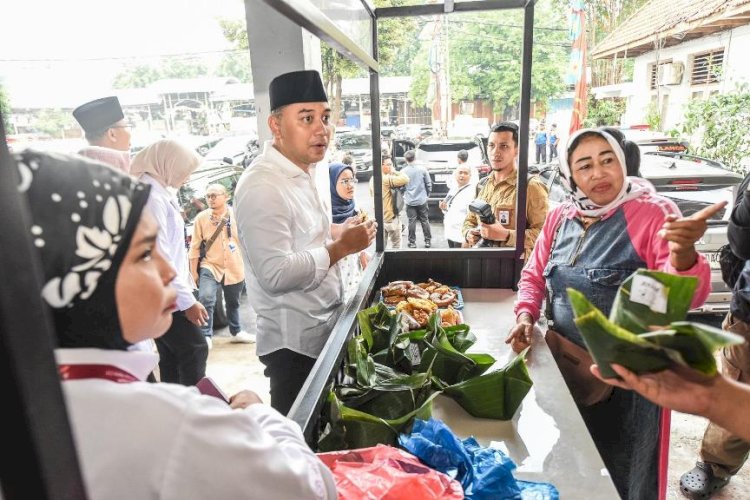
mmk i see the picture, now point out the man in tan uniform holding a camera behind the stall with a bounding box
[462,122,548,257]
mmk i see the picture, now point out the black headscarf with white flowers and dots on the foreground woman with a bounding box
[16,150,150,349]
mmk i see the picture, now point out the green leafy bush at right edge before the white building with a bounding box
[672,86,750,174]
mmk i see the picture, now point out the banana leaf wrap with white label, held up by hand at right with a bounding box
[568,269,743,378]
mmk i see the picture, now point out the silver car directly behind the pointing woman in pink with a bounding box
[539,152,742,319]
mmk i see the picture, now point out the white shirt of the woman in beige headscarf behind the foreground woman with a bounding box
[139,174,196,311]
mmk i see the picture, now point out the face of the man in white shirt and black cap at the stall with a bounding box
[268,102,331,170]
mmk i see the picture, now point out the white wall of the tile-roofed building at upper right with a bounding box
[623,25,750,130]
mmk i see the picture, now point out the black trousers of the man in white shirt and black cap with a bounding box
[258,349,316,415]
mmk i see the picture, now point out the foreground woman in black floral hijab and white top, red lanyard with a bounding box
[17,151,336,500]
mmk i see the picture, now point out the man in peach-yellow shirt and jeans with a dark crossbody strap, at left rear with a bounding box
[188,184,255,347]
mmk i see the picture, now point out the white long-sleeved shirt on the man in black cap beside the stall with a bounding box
[234,141,343,358]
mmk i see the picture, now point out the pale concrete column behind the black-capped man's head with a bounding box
[245,0,322,141]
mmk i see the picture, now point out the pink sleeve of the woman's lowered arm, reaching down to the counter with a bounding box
[513,204,567,321]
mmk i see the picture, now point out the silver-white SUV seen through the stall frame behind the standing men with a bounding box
[392,138,490,221]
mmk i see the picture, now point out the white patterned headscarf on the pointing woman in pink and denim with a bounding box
[560,128,654,217]
